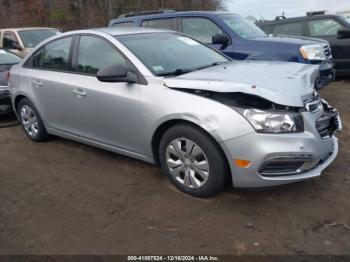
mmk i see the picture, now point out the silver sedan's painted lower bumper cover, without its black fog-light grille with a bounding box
[222,133,338,188]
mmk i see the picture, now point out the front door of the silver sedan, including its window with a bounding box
[67,35,143,154]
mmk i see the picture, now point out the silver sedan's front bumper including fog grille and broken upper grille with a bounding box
[220,101,342,188]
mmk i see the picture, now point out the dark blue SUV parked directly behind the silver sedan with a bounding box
[109,10,335,89]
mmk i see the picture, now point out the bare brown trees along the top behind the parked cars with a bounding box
[0,0,224,30]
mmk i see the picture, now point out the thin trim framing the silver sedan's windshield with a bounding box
[113,31,233,78]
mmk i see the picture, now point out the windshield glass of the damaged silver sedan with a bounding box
[116,33,230,76]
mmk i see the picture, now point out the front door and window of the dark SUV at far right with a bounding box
[307,18,350,72]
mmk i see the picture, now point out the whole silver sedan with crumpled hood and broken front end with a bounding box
[10,28,341,197]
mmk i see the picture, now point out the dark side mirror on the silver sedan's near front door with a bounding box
[96,65,138,83]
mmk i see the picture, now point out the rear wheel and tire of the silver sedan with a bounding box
[17,98,49,142]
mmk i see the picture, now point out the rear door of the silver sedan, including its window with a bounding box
[24,37,77,133]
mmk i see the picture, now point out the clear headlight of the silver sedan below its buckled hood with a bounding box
[242,109,304,133]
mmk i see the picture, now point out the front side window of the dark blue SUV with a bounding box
[182,17,223,44]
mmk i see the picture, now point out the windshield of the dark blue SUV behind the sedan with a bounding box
[220,15,266,39]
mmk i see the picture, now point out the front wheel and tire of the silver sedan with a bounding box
[159,124,229,198]
